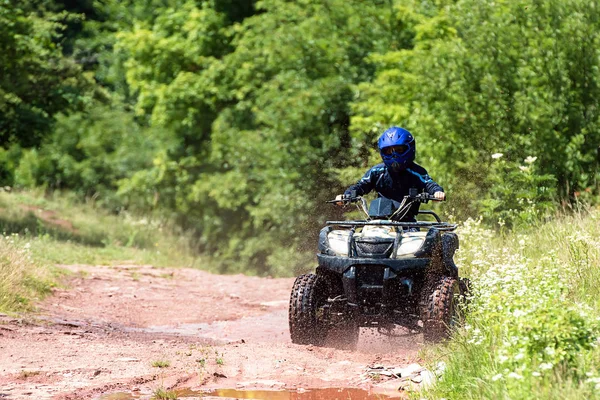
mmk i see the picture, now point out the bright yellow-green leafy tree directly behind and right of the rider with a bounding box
[353,0,600,216]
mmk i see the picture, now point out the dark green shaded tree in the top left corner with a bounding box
[0,0,89,150]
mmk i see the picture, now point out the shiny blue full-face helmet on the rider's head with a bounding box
[378,126,416,170]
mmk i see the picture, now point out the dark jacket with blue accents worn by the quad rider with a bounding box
[346,162,444,221]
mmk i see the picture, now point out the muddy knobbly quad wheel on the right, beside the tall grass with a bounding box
[421,276,461,342]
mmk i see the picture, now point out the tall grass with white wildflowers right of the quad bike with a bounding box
[421,210,600,399]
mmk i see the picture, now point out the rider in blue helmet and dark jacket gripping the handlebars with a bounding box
[336,126,446,222]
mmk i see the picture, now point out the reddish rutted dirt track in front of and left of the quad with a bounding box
[0,265,421,399]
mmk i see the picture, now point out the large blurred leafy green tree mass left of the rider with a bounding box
[119,0,392,273]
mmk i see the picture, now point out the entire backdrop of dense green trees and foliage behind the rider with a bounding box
[0,0,600,274]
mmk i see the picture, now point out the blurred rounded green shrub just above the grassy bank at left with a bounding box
[14,101,169,210]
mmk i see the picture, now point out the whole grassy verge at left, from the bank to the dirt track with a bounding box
[0,191,206,312]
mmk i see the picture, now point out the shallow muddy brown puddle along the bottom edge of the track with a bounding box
[99,388,403,400]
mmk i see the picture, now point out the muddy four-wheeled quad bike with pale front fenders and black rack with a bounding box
[289,190,467,349]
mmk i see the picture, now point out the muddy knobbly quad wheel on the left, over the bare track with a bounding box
[289,274,328,346]
